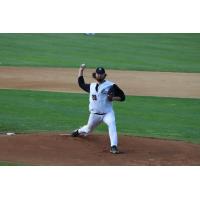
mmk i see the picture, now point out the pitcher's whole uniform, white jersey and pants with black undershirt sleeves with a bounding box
[78,72,125,146]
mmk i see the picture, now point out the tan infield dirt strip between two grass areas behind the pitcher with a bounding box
[0,67,200,98]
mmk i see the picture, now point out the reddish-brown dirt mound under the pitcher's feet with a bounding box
[0,134,200,166]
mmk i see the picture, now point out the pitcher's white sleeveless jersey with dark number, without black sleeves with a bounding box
[89,80,114,114]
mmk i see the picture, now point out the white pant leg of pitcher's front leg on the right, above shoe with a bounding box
[103,111,118,146]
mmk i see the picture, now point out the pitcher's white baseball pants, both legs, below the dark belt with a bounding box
[78,111,118,146]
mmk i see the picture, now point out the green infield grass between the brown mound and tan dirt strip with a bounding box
[0,90,200,143]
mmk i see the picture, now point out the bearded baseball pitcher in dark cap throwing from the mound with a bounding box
[71,64,125,154]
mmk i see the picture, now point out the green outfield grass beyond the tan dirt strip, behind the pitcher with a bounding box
[0,33,200,72]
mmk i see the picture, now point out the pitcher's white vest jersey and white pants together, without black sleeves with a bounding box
[78,80,117,146]
